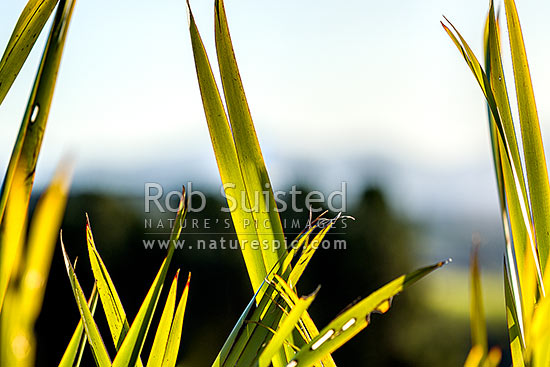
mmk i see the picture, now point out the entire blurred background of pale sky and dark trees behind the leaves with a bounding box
[0,0,550,366]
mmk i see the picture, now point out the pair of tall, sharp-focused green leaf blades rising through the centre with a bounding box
[188,1,334,367]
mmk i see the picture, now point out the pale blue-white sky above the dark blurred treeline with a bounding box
[0,0,550,217]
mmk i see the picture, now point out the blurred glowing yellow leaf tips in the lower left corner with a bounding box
[0,162,70,366]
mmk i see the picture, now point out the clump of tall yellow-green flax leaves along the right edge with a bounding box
[446,0,550,367]
